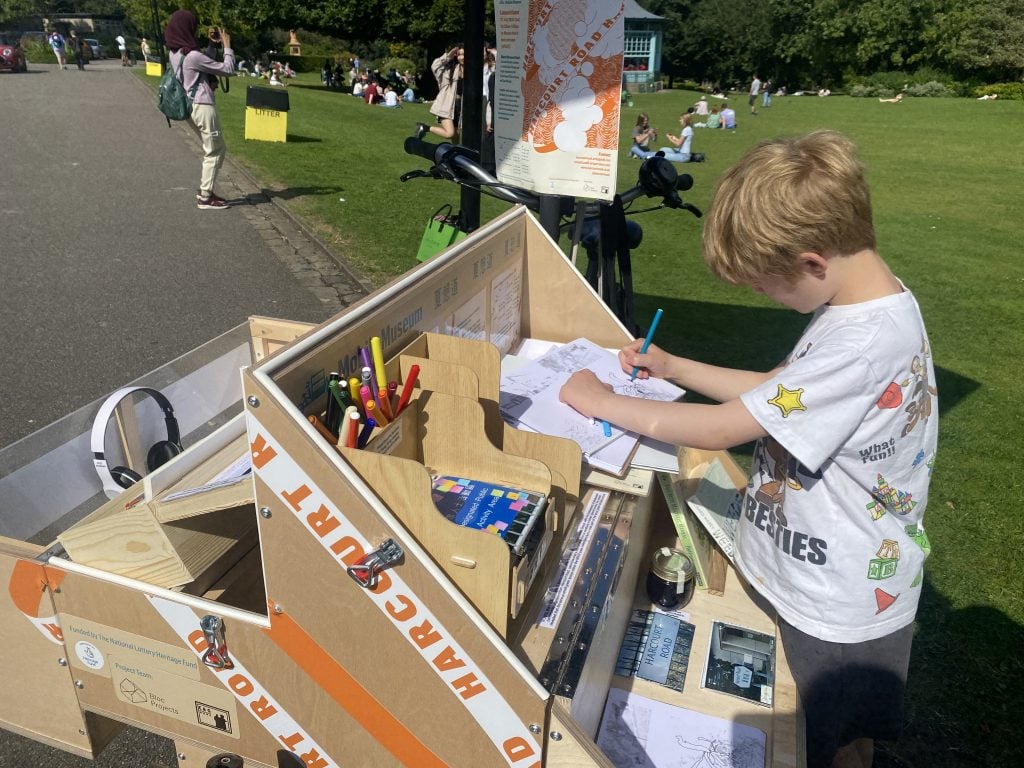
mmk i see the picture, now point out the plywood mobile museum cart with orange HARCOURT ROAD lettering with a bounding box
[0,210,803,768]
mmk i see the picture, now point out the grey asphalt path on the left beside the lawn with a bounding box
[0,59,369,768]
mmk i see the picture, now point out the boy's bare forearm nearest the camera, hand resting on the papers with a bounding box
[559,370,767,451]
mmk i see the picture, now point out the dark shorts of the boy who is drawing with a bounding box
[778,618,913,768]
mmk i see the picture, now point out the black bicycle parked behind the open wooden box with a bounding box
[401,136,701,336]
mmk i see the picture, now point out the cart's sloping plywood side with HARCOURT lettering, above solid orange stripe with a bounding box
[244,374,547,767]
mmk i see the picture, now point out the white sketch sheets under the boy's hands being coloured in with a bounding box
[500,339,683,456]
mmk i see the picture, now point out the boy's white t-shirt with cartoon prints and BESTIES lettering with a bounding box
[736,291,938,642]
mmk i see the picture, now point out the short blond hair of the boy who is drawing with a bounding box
[703,131,874,285]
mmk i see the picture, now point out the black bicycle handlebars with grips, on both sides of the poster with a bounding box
[401,136,701,217]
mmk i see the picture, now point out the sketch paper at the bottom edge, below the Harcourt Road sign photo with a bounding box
[597,688,767,768]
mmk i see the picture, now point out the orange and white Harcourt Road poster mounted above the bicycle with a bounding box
[494,0,625,200]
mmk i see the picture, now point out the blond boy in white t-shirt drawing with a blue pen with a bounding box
[561,131,938,768]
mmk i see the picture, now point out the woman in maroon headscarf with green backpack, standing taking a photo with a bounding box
[164,9,234,211]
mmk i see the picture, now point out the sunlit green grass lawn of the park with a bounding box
[144,69,1024,768]
